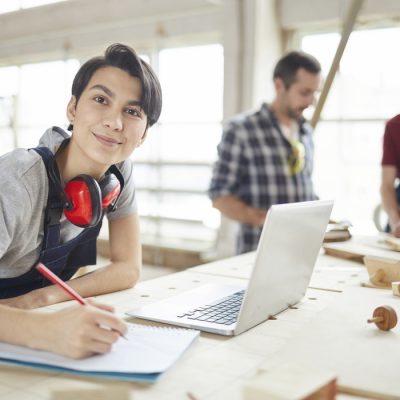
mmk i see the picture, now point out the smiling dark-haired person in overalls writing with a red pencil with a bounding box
[0,44,162,356]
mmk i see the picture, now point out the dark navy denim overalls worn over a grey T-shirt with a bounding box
[0,147,104,299]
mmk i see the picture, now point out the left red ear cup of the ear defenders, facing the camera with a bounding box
[64,175,102,228]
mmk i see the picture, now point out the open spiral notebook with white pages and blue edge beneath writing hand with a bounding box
[0,324,199,382]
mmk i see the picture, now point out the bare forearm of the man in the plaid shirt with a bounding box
[213,195,267,225]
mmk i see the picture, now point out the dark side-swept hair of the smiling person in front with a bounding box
[68,43,162,130]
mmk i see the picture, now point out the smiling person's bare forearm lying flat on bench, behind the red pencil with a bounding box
[4,262,140,309]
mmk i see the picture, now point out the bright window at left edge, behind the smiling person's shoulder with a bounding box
[0,60,79,154]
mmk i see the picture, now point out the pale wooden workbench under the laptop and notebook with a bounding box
[0,248,400,400]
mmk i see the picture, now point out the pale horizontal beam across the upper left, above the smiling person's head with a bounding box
[0,0,222,65]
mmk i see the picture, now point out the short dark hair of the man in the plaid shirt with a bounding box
[273,51,321,89]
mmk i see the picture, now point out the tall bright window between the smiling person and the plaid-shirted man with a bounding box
[133,44,223,249]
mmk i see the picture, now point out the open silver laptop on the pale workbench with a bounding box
[127,200,333,336]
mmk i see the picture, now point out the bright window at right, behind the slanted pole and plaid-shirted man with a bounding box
[302,28,400,234]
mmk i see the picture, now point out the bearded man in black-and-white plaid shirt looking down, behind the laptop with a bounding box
[209,51,321,254]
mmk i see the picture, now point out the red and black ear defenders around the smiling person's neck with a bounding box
[49,139,124,228]
